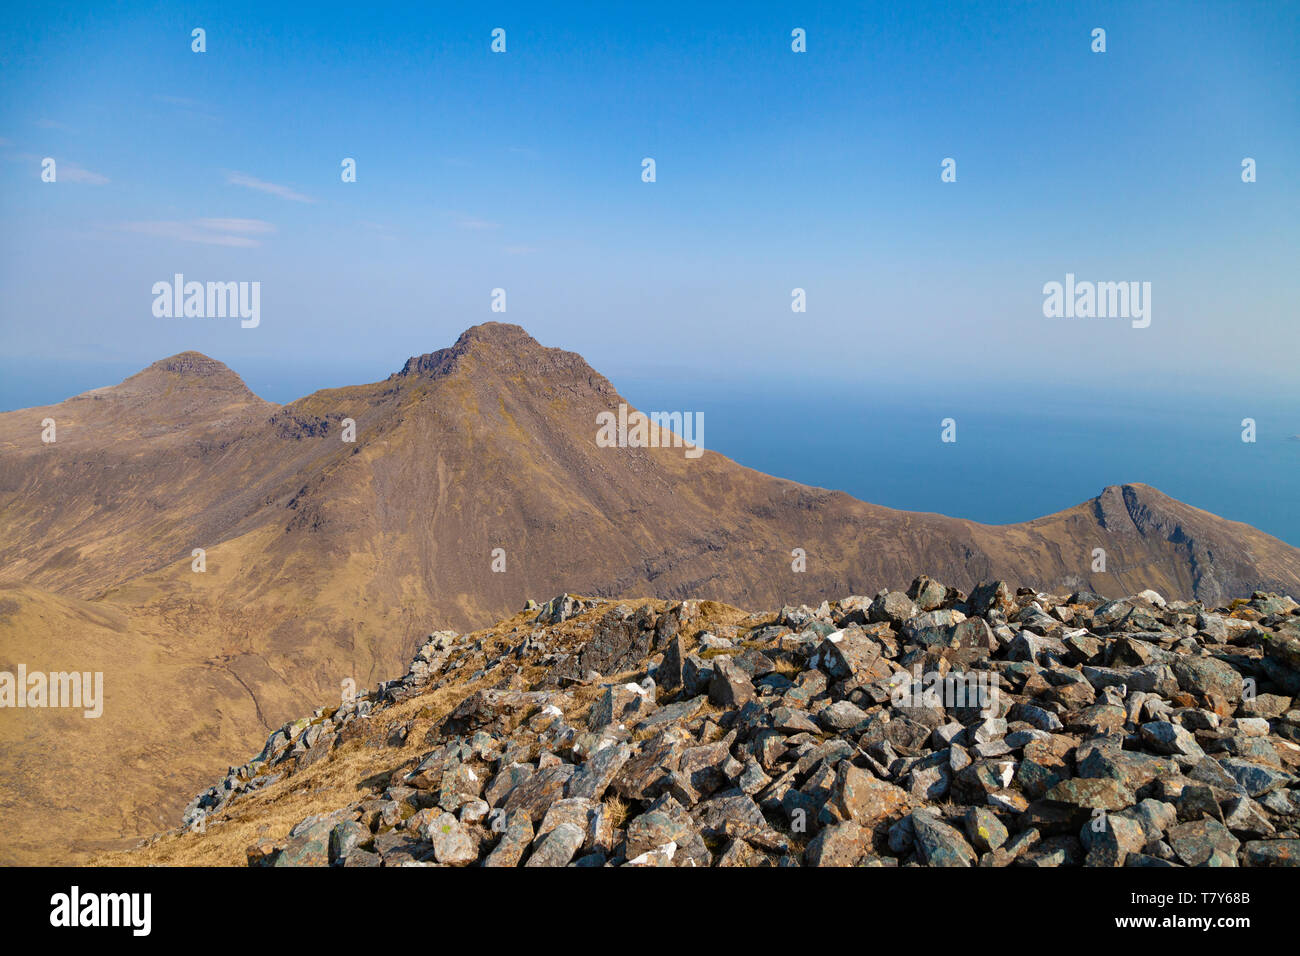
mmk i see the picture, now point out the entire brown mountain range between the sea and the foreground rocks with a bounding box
[0,323,1300,861]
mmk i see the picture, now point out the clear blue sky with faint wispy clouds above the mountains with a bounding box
[0,0,1300,407]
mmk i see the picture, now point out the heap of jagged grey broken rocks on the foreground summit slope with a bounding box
[178,578,1300,866]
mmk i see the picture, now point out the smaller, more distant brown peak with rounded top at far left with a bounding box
[0,352,276,597]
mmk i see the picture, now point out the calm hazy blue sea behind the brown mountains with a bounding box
[0,359,1300,546]
